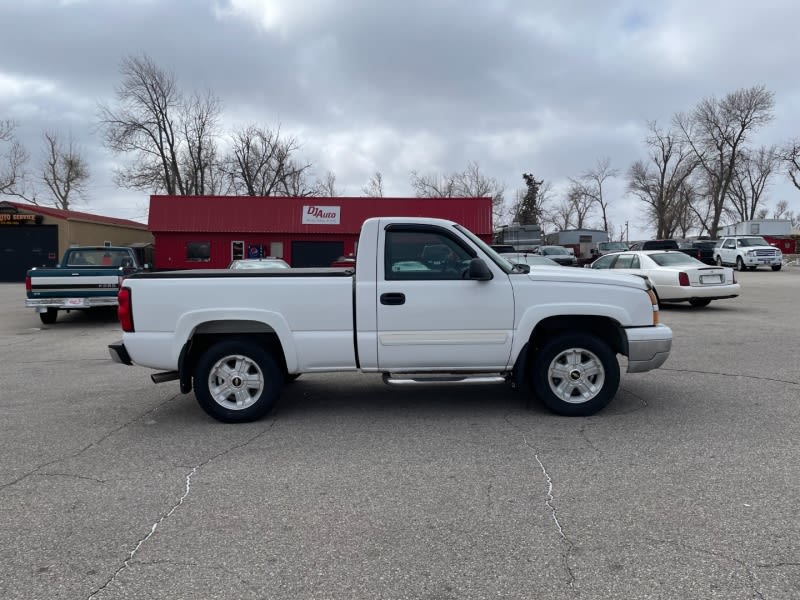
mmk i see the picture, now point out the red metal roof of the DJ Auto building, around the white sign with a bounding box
[148,196,492,235]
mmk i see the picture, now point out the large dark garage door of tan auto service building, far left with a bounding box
[0,225,60,281]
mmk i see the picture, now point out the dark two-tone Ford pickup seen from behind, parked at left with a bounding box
[25,246,144,324]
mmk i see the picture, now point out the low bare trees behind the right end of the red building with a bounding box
[411,162,505,220]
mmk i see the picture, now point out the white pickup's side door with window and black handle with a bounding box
[376,224,514,371]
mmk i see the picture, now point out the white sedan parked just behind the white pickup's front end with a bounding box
[589,250,740,306]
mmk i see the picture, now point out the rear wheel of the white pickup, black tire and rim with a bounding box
[194,340,285,423]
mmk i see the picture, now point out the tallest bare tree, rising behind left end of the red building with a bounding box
[100,56,225,195]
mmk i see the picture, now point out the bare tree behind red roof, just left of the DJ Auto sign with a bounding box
[224,124,314,196]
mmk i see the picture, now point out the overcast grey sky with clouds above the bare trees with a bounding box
[0,0,800,239]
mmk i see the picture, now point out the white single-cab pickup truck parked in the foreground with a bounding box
[109,217,672,422]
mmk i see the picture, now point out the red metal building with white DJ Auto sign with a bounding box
[148,196,492,269]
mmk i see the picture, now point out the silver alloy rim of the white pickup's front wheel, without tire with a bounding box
[547,348,606,404]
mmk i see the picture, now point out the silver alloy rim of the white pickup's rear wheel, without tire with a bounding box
[208,354,264,410]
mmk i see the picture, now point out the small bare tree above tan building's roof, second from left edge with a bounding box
[39,132,89,210]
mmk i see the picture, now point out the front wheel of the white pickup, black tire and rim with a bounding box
[530,333,619,417]
